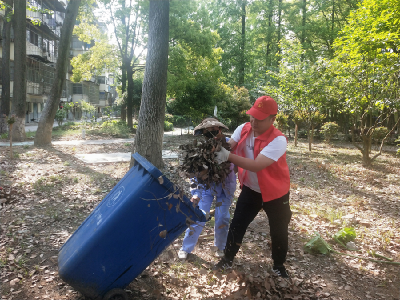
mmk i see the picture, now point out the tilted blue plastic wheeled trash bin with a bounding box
[58,153,206,299]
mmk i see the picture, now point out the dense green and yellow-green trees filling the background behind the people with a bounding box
[72,0,400,165]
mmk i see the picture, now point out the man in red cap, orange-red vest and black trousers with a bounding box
[214,96,292,278]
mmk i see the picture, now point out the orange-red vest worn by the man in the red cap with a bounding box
[235,123,290,202]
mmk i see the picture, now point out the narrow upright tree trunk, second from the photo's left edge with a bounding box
[11,1,26,142]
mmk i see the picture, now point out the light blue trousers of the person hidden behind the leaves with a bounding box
[181,184,233,253]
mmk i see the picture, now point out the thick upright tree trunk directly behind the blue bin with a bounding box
[131,0,169,168]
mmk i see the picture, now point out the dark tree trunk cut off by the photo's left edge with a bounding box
[0,0,13,133]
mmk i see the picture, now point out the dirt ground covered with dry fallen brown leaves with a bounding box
[0,135,400,300]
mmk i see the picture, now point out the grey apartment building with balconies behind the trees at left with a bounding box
[0,0,116,123]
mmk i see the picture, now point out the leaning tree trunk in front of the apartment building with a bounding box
[34,0,81,146]
